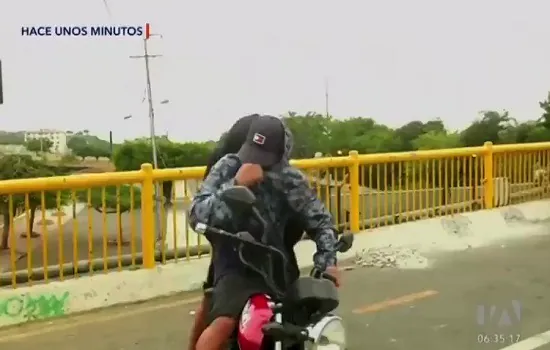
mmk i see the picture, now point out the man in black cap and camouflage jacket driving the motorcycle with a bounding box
[190,116,338,350]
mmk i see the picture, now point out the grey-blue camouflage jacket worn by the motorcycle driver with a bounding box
[189,154,337,274]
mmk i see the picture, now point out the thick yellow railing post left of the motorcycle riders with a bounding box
[141,163,155,269]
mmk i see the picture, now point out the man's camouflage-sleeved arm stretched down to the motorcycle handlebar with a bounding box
[282,167,337,270]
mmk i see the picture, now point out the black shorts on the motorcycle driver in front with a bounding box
[207,272,268,324]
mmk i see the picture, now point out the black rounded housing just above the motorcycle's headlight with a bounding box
[287,276,339,314]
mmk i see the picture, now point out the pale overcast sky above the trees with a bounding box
[0,0,550,140]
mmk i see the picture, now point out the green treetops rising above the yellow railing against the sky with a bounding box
[104,95,550,175]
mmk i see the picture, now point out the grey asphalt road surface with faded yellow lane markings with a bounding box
[0,232,550,350]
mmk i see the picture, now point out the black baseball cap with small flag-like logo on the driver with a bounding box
[237,115,285,168]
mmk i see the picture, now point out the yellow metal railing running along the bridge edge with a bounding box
[0,142,550,287]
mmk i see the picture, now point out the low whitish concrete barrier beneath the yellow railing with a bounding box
[0,200,550,327]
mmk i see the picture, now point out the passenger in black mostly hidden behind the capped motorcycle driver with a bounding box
[188,114,316,350]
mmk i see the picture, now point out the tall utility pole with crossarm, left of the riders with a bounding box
[130,34,162,241]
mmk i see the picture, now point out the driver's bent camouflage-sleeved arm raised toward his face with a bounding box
[189,155,240,231]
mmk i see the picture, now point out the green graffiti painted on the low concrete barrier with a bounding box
[0,292,69,321]
